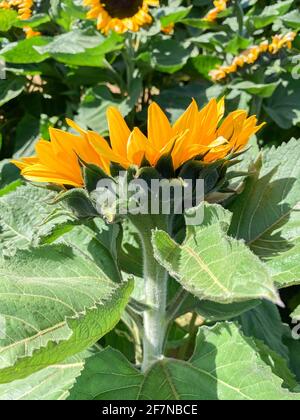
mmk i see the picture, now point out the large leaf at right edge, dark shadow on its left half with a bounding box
[230,139,300,286]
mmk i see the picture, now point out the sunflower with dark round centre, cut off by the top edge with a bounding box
[83,0,159,34]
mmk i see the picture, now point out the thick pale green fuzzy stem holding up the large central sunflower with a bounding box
[131,215,168,372]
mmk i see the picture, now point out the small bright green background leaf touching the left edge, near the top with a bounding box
[0,36,52,64]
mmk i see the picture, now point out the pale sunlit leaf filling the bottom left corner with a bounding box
[0,357,84,401]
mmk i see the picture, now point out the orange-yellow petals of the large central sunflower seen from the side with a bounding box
[13,99,264,187]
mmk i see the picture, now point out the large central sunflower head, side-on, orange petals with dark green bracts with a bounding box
[13,98,263,223]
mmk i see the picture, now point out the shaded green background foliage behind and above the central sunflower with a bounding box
[0,0,300,165]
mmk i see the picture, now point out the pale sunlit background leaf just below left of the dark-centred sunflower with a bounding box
[35,30,123,67]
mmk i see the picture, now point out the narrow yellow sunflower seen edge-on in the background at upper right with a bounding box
[209,32,297,82]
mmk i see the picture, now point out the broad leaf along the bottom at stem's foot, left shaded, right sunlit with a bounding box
[70,323,300,401]
